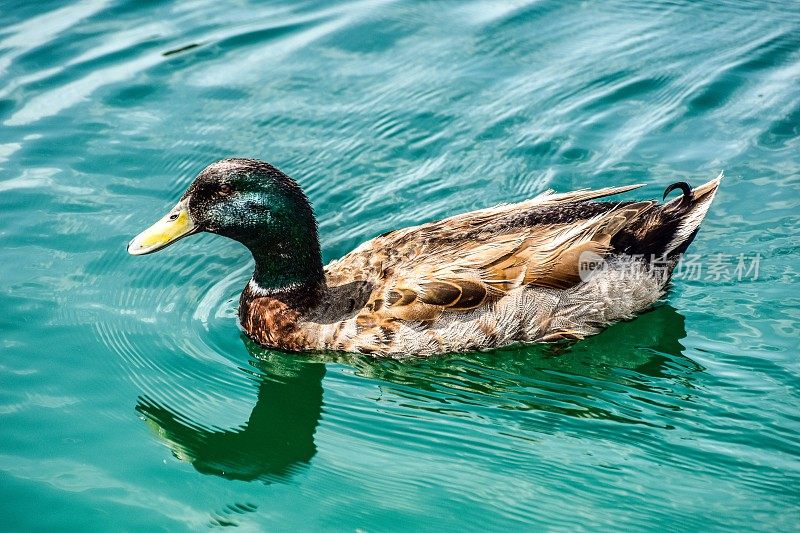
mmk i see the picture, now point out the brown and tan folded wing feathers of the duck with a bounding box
[327,186,654,327]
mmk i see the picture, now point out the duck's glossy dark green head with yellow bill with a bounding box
[128,158,322,284]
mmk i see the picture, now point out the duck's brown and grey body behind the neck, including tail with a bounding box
[299,178,719,355]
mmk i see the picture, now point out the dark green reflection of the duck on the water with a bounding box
[136,305,703,481]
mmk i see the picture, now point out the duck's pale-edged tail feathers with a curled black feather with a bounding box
[662,172,723,256]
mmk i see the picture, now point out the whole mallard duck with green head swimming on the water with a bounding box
[128,159,722,356]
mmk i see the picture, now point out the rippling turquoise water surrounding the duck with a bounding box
[0,0,800,532]
